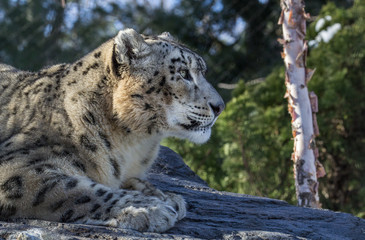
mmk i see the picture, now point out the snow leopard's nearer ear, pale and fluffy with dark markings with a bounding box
[114,28,151,65]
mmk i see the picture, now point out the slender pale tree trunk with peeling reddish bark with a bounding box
[279,0,325,208]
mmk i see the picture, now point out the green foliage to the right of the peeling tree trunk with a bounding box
[308,0,365,215]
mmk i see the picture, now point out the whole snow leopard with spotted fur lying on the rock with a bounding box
[0,29,224,232]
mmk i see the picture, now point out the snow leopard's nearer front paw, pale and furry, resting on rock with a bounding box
[116,203,178,232]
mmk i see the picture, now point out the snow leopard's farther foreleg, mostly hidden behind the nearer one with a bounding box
[123,178,186,220]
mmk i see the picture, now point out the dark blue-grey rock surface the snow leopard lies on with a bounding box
[0,147,365,240]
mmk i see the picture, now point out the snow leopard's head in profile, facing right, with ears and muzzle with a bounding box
[109,29,224,143]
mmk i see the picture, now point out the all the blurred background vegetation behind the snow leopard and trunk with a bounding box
[0,0,365,217]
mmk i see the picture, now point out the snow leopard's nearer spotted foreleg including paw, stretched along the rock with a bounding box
[0,164,178,232]
